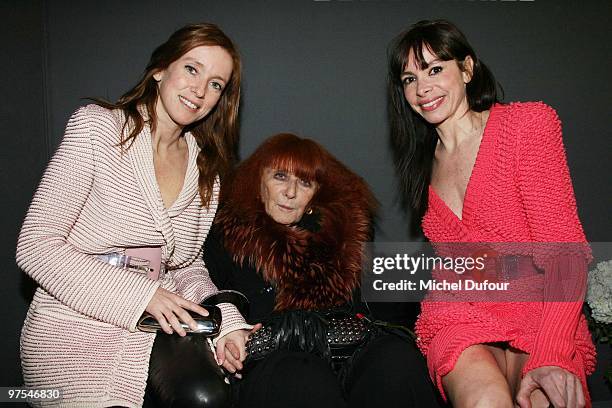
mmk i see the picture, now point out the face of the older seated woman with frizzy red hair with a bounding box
[261,167,317,225]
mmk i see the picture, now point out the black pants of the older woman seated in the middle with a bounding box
[239,335,444,408]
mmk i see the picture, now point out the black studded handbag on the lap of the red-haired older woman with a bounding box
[245,310,377,366]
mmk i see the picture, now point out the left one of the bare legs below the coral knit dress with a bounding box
[442,344,520,408]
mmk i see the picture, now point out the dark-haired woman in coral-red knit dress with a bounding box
[389,20,595,408]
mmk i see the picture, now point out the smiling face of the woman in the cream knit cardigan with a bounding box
[153,45,233,131]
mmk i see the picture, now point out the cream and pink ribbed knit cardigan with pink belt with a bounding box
[17,105,250,407]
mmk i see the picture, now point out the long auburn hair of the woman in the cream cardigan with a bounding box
[94,23,241,205]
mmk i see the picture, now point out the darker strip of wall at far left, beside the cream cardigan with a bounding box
[0,0,49,386]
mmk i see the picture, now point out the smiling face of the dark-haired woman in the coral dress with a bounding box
[401,46,473,126]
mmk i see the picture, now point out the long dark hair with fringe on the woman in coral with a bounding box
[387,20,502,216]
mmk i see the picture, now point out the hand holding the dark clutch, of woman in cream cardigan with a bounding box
[145,287,208,336]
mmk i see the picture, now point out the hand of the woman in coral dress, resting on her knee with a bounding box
[516,366,586,408]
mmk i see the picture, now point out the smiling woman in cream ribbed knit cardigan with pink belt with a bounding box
[17,24,251,407]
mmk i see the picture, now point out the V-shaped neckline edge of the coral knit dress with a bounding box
[429,104,499,223]
